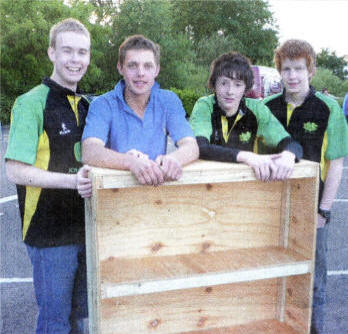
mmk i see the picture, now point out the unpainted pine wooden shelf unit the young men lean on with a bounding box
[86,161,318,334]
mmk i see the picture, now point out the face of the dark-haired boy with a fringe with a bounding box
[215,76,246,116]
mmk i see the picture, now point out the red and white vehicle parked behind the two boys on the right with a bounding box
[246,65,283,99]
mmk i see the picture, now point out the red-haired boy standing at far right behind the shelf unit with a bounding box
[264,40,348,333]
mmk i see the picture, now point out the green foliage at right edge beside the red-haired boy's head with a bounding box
[312,68,348,97]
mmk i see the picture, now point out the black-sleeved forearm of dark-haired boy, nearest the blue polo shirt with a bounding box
[197,137,240,162]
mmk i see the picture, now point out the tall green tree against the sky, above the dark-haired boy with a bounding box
[171,0,277,65]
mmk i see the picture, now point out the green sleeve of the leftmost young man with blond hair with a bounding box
[5,86,48,165]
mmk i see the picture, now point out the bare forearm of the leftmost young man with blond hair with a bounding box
[6,160,77,189]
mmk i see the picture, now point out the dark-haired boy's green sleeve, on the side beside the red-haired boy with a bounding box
[247,99,290,147]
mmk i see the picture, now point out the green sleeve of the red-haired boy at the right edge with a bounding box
[325,97,348,160]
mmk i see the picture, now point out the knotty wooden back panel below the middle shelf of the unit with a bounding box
[100,280,277,334]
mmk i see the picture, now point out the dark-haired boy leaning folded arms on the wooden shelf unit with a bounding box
[190,52,302,181]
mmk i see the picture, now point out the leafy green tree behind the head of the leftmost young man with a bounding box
[0,0,111,122]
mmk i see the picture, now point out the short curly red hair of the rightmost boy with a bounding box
[274,39,316,73]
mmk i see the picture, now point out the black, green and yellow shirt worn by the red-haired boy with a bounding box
[264,87,348,182]
